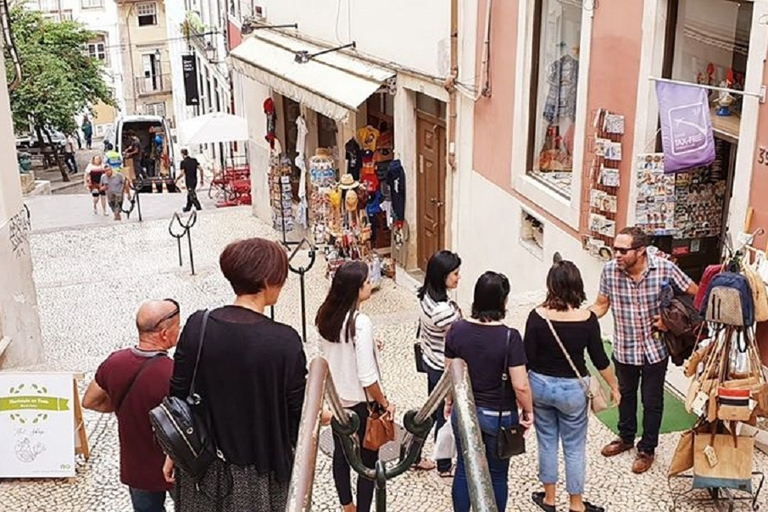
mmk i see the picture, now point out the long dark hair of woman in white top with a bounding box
[315,261,368,343]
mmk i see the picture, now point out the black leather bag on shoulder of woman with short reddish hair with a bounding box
[149,310,223,481]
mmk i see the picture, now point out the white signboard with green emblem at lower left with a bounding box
[0,372,76,478]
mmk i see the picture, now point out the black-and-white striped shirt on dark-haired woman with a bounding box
[419,293,461,371]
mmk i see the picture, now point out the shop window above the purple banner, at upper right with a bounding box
[663,0,754,142]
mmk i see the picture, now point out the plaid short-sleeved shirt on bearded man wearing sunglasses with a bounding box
[600,254,693,366]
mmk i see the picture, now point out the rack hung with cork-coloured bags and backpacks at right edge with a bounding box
[669,247,768,510]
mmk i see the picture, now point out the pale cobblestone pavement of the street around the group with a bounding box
[0,196,768,512]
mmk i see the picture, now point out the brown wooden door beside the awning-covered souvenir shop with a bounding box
[416,112,446,271]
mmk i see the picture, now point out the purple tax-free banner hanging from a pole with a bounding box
[656,82,715,172]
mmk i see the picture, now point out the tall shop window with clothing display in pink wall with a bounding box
[527,0,582,197]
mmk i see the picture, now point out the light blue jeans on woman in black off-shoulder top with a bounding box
[528,372,589,494]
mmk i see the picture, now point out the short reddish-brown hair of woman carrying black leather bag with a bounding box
[219,238,288,295]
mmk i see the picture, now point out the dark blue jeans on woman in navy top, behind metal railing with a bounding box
[451,407,519,512]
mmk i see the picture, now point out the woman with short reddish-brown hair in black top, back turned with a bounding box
[165,238,307,512]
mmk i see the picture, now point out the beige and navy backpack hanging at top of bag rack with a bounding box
[701,272,755,327]
